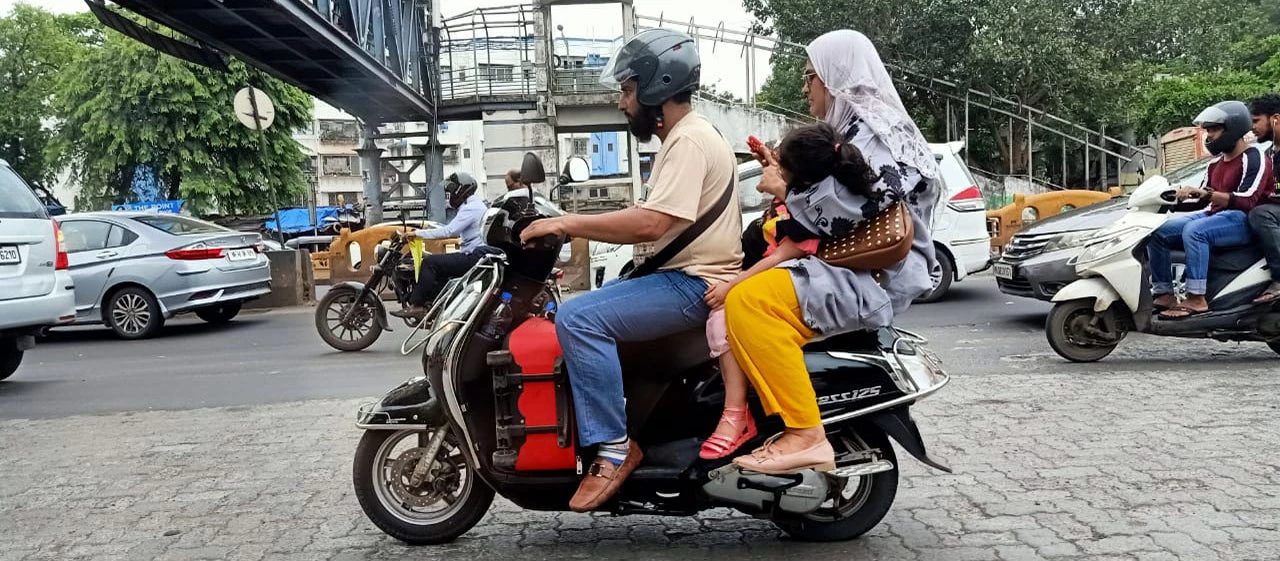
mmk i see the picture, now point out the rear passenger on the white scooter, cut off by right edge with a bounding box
[1249,94,1280,304]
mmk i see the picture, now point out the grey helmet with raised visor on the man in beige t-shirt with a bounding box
[600,29,703,106]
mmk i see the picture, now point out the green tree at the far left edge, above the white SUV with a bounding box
[0,4,93,184]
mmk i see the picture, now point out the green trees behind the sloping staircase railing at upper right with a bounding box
[744,0,1274,178]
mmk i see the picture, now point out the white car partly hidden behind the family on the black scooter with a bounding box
[591,142,991,302]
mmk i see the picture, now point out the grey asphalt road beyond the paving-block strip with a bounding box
[0,275,1265,419]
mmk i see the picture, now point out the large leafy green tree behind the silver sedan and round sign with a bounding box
[58,26,311,214]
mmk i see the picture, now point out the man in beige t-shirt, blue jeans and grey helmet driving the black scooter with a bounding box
[521,29,742,512]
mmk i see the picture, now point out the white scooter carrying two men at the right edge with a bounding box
[1044,177,1280,362]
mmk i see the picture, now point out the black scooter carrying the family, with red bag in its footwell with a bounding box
[353,156,950,544]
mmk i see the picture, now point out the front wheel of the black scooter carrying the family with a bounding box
[351,429,494,546]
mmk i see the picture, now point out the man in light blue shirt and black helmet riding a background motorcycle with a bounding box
[390,172,495,319]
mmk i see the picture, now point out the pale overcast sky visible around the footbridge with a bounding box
[0,0,769,97]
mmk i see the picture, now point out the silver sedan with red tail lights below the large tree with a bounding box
[58,213,271,339]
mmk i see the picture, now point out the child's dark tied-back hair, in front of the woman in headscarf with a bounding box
[778,123,879,196]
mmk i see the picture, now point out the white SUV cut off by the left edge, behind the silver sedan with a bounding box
[0,160,76,380]
